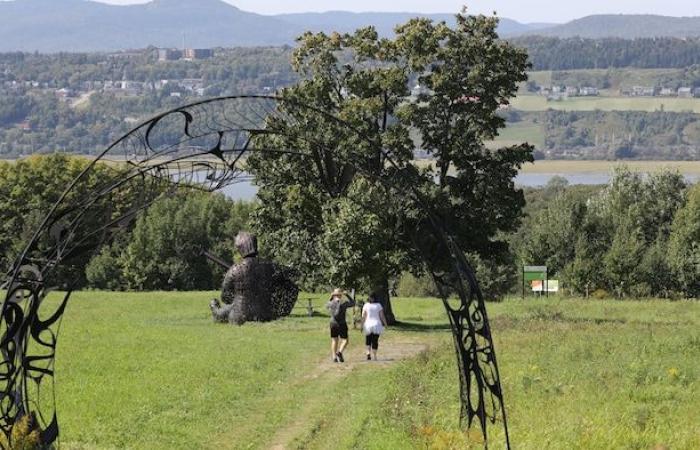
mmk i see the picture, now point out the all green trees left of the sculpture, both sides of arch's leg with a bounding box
[0,154,253,289]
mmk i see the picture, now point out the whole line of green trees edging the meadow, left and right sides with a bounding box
[0,155,700,299]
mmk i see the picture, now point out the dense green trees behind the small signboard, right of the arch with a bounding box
[512,167,698,298]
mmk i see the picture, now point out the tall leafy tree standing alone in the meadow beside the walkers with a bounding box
[248,9,532,320]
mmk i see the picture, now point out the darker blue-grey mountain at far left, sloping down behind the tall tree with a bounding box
[0,0,302,52]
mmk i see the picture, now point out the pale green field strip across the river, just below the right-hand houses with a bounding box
[511,95,700,113]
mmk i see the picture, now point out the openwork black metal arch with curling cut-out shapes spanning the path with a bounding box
[0,96,510,447]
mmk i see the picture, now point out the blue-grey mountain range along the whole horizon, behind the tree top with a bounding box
[0,0,700,52]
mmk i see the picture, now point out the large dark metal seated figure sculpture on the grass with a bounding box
[209,232,299,325]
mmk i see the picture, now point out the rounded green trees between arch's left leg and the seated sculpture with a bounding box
[109,192,251,290]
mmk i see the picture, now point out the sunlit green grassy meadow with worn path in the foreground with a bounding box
[34,292,700,449]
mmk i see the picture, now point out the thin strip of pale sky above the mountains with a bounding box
[85,0,700,23]
